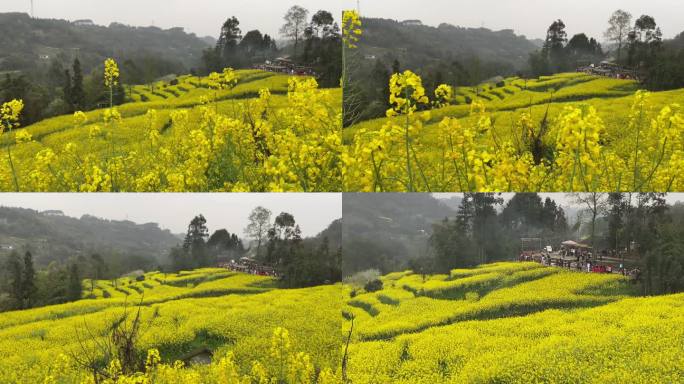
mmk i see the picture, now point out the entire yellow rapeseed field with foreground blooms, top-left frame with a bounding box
[0,70,341,192]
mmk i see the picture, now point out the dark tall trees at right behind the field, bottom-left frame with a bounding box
[166,207,342,288]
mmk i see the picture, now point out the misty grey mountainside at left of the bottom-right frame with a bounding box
[342,193,456,275]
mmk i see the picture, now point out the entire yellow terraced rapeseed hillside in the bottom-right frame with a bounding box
[345,263,684,383]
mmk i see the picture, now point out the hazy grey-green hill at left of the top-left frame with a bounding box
[0,13,209,73]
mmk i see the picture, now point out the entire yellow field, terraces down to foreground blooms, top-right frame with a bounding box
[343,73,684,192]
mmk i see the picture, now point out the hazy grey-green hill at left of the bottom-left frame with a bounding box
[0,206,181,267]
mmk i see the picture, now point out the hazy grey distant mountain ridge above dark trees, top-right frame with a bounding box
[361,18,538,69]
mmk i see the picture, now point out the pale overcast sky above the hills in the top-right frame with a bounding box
[344,0,684,41]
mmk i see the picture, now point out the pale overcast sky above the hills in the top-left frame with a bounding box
[0,0,345,37]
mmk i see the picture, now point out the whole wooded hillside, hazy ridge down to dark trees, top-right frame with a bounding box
[343,18,535,127]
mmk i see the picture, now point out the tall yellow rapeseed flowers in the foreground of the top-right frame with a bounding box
[343,71,684,192]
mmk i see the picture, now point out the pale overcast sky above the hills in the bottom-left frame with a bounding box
[0,194,342,237]
